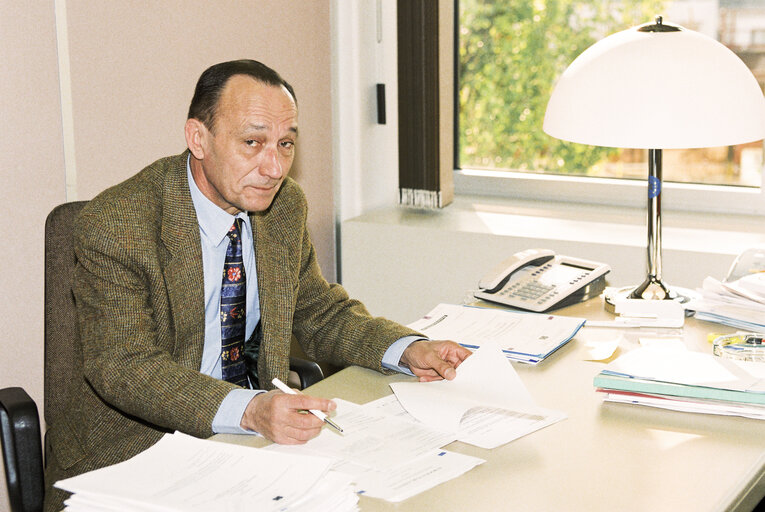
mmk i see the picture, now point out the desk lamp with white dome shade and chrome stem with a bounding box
[543,16,765,306]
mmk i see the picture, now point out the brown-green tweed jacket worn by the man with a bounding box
[46,151,414,508]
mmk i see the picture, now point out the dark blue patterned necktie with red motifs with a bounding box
[220,218,249,387]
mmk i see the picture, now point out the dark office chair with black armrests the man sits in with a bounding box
[0,201,324,512]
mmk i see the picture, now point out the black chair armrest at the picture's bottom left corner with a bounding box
[0,387,45,512]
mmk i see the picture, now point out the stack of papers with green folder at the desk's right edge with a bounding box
[594,347,765,419]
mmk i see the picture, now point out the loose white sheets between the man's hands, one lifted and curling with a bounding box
[266,345,566,502]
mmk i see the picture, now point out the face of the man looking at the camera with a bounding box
[186,75,297,215]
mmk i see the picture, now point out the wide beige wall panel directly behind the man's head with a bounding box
[67,0,335,279]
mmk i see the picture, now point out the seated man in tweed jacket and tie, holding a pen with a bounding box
[46,60,469,510]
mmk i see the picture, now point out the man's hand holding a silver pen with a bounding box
[241,390,337,444]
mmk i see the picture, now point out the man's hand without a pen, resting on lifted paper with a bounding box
[401,341,472,382]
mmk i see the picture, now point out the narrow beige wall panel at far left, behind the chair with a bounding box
[0,0,65,511]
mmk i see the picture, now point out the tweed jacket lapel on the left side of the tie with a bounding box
[160,151,205,370]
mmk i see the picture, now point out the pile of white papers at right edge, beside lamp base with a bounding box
[686,272,765,332]
